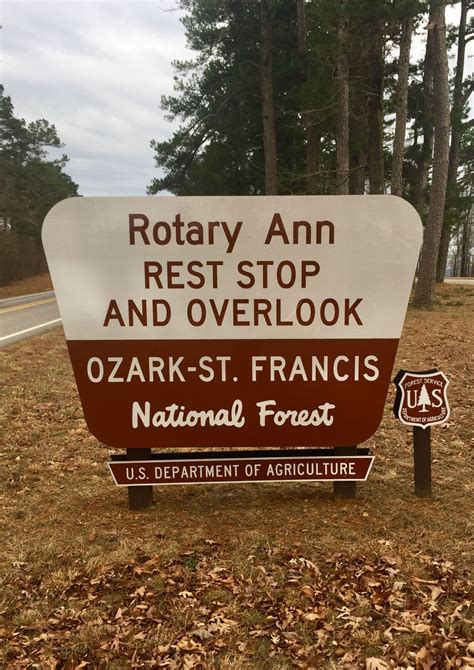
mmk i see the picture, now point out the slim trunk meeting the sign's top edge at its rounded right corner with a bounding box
[392,17,413,196]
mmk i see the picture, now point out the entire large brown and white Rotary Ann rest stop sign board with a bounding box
[43,196,421,448]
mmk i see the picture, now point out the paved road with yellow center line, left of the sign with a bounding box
[0,291,61,347]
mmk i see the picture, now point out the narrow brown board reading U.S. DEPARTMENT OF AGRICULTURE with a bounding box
[108,456,374,486]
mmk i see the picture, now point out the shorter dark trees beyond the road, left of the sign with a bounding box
[0,85,77,286]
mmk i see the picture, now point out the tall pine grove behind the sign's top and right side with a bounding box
[148,0,473,308]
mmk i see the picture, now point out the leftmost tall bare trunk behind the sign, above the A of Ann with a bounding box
[260,0,278,195]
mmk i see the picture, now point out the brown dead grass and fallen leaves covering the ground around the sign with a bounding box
[0,286,474,670]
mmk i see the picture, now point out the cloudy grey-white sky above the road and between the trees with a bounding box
[0,0,472,196]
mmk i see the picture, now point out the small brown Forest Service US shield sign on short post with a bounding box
[394,370,450,428]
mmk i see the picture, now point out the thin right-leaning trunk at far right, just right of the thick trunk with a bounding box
[436,0,468,282]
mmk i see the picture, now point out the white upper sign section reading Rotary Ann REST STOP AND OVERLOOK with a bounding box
[43,196,422,340]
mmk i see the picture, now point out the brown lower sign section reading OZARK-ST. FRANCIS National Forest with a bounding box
[68,339,398,449]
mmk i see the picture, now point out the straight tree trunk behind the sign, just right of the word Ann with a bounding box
[336,6,349,195]
